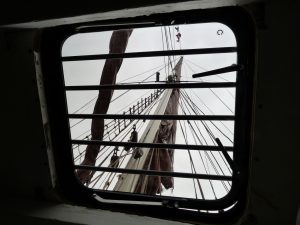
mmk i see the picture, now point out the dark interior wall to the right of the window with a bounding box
[250,1,300,224]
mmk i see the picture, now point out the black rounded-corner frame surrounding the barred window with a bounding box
[39,7,255,223]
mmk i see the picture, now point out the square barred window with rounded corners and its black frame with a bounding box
[40,7,254,222]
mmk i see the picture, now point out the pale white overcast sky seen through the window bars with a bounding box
[62,23,237,199]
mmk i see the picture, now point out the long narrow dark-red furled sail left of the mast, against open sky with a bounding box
[77,29,132,183]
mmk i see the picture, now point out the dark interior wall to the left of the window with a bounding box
[0,31,50,197]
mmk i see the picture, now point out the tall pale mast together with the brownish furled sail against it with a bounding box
[114,57,183,195]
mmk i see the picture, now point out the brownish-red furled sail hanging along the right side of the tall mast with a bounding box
[135,57,183,195]
